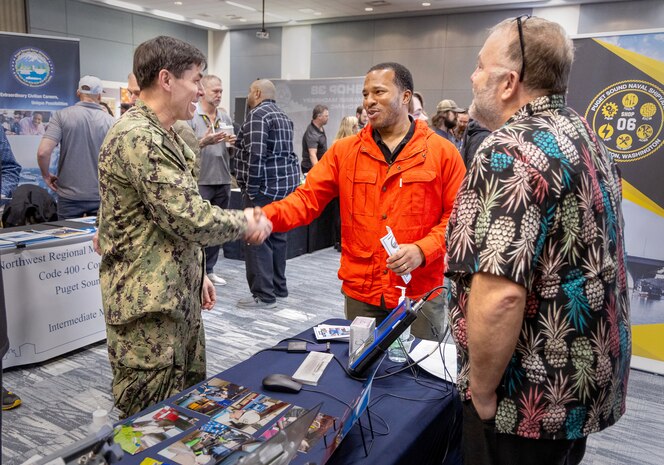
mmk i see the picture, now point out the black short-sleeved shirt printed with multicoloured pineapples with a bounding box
[446,95,631,439]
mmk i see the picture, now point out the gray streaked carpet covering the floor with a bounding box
[2,248,664,465]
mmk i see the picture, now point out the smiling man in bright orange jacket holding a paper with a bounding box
[264,63,466,339]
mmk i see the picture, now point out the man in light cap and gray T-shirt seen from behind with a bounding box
[37,76,115,220]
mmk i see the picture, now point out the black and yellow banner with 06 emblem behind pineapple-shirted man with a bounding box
[568,33,664,371]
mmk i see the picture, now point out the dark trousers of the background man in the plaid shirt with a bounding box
[242,192,288,303]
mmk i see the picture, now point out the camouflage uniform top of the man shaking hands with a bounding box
[99,100,247,325]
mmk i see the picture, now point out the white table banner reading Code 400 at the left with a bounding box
[2,236,106,368]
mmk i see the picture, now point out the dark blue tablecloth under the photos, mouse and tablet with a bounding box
[113,319,461,465]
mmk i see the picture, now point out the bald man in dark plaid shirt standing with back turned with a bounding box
[234,79,300,308]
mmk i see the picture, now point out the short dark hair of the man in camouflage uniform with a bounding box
[133,36,207,89]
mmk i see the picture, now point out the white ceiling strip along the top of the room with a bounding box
[83,0,613,29]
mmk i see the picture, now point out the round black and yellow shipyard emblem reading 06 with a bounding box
[586,80,664,162]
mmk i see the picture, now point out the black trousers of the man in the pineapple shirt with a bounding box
[462,401,586,465]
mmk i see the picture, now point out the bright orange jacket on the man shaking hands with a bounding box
[264,121,466,308]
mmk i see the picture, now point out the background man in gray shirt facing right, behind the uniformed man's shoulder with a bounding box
[189,74,235,286]
